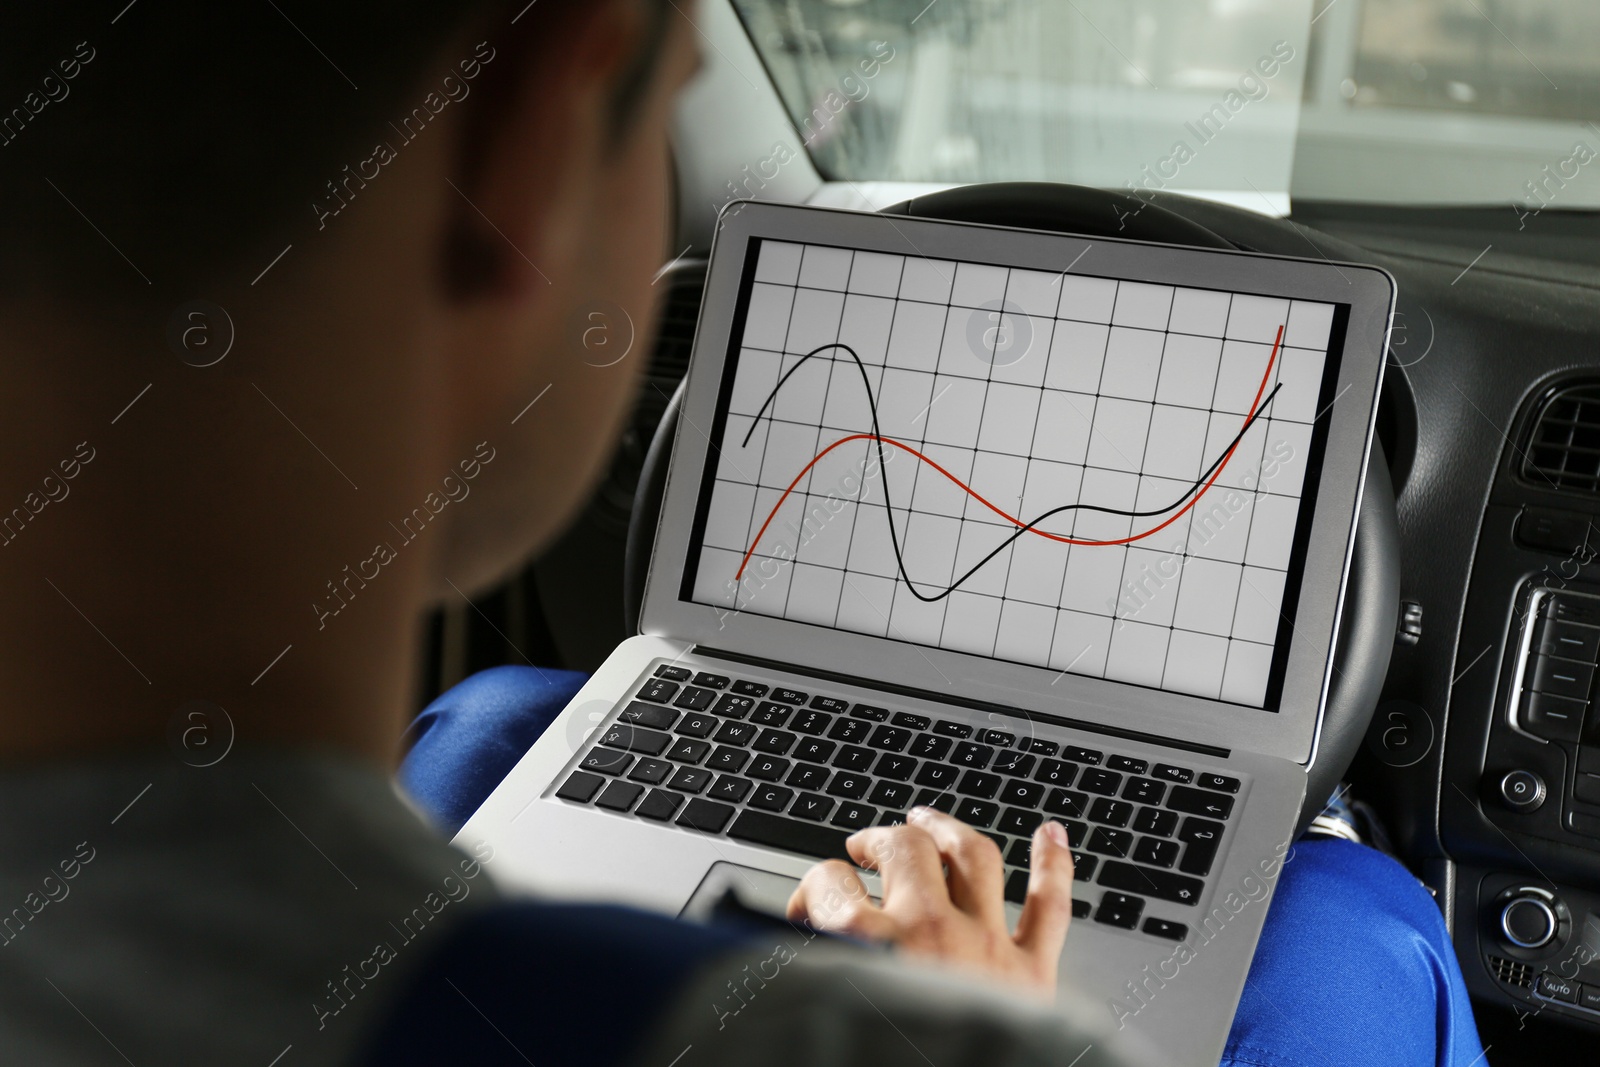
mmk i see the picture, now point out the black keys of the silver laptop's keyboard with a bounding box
[555,664,1240,941]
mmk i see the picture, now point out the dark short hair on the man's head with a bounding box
[0,0,664,299]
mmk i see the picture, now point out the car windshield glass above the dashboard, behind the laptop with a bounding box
[734,0,1600,213]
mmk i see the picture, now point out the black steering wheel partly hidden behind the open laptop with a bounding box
[622,182,1400,835]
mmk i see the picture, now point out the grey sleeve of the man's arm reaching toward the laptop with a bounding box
[632,934,1157,1067]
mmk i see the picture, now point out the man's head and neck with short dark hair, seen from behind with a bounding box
[0,0,696,767]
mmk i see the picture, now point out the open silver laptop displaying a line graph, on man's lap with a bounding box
[458,202,1394,1064]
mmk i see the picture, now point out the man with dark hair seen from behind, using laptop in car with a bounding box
[0,0,1478,1067]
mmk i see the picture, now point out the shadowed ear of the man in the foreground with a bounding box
[442,0,651,302]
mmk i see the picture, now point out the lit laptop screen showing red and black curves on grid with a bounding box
[680,240,1349,710]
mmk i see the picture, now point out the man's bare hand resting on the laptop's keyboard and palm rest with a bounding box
[789,808,1072,997]
